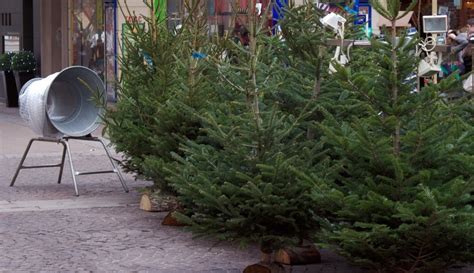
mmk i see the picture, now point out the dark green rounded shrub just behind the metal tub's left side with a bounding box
[12,51,36,93]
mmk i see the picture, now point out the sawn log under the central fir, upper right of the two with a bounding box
[275,245,321,265]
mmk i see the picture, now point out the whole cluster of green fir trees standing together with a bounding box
[105,0,474,272]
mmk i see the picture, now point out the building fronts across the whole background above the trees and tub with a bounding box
[0,0,474,99]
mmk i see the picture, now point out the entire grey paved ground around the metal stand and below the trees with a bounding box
[0,104,474,273]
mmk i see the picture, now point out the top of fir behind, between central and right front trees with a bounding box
[275,3,368,126]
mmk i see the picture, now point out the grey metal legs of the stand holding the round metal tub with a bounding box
[10,136,128,196]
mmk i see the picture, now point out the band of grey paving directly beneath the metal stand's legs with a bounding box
[0,154,142,201]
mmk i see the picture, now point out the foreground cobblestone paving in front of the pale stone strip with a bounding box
[0,207,258,272]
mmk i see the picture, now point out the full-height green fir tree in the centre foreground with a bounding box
[168,1,324,254]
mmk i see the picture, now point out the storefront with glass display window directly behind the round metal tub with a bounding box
[34,0,117,99]
